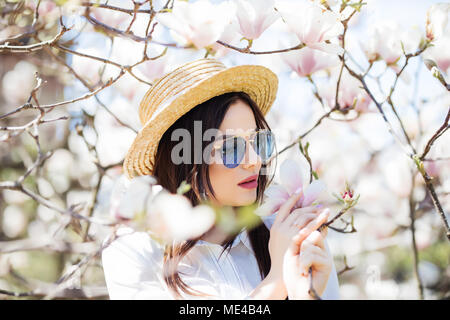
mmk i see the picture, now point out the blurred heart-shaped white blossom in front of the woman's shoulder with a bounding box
[147,191,216,243]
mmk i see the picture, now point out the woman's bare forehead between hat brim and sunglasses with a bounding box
[219,100,257,135]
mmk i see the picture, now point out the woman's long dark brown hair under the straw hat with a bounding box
[153,92,273,297]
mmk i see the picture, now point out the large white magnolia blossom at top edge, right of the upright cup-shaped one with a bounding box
[276,1,344,54]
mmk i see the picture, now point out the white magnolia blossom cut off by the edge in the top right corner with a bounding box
[426,3,450,40]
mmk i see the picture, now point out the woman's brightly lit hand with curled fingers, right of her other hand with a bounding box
[283,221,332,299]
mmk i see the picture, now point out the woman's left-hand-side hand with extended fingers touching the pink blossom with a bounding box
[269,191,323,281]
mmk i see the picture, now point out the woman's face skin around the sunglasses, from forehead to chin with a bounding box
[209,100,262,206]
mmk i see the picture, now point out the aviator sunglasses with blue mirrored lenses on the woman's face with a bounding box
[213,129,275,169]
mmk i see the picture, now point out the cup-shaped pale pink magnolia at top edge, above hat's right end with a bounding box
[236,0,279,39]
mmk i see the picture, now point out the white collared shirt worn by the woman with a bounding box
[102,215,339,300]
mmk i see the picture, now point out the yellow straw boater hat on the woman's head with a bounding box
[123,58,278,179]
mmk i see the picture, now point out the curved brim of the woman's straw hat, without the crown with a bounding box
[123,65,278,179]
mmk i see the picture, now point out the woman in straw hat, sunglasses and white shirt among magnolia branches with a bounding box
[102,59,338,299]
